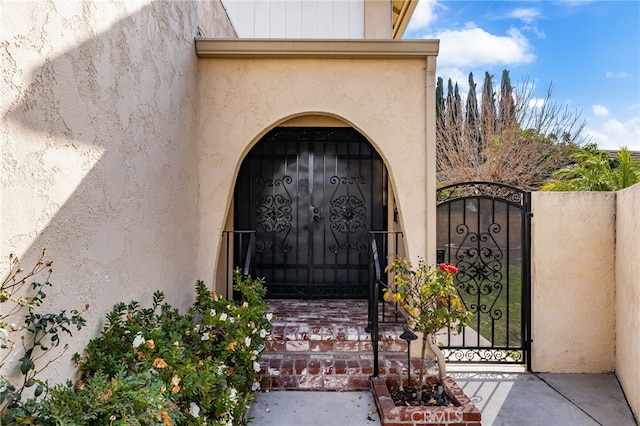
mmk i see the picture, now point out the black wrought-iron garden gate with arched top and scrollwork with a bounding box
[437,182,531,366]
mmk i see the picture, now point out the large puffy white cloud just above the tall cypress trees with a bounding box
[429,23,536,68]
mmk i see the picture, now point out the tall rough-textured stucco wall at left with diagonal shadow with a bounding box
[0,0,233,382]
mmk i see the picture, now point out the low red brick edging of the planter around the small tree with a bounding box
[371,376,482,426]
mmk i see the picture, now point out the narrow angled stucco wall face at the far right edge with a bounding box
[615,184,640,418]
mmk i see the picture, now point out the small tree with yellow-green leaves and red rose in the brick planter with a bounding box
[383,256,471,396]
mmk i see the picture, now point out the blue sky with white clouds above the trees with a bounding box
[404,0,640,151]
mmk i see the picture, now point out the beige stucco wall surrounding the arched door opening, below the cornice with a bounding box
[197,49,435,290]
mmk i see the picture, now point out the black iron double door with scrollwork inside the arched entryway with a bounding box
[234,127,387,298]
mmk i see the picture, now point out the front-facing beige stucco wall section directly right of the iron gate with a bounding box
[532,192,616,373]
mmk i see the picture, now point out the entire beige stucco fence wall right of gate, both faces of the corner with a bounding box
[531,185,640,416]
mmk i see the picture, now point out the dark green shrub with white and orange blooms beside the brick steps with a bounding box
[74,271,271,425]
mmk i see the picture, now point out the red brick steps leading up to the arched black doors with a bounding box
[260,300,436,391]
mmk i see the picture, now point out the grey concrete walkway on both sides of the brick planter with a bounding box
[249,366,637,426]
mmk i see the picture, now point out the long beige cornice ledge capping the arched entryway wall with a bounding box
[195,38,440,59]
